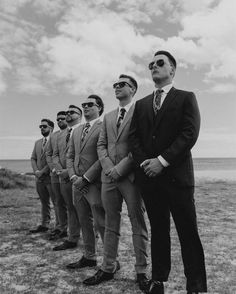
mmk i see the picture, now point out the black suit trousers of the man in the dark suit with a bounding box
[142,177,207,292]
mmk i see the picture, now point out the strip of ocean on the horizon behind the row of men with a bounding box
[0,158,236,180]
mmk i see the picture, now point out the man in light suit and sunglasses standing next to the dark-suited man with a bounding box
[83,75,148,289]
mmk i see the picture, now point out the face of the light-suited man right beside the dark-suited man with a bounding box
[113,78,135,100]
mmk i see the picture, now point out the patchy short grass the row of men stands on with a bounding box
[0,175,236,294]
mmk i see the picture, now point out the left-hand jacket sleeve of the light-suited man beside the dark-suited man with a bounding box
[97,116,114,173]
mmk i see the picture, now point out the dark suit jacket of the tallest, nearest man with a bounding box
[129,87,200,186]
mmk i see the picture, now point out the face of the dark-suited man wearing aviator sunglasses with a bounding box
[149,54,174,84]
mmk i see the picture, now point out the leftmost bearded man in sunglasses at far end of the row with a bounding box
[30,118,55,234]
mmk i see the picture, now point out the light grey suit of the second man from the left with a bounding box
[46,131,67,232]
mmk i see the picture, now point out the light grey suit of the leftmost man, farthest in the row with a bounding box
[31,138,53,227]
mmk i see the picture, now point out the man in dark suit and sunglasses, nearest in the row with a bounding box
[129,51,207,294]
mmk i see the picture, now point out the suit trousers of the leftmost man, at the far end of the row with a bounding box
[36,181,53,227]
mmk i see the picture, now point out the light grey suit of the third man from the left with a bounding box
[53,129,80,242]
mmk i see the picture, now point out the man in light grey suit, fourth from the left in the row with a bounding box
[67,95,105,269]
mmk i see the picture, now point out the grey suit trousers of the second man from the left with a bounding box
[51,177,67,232]
